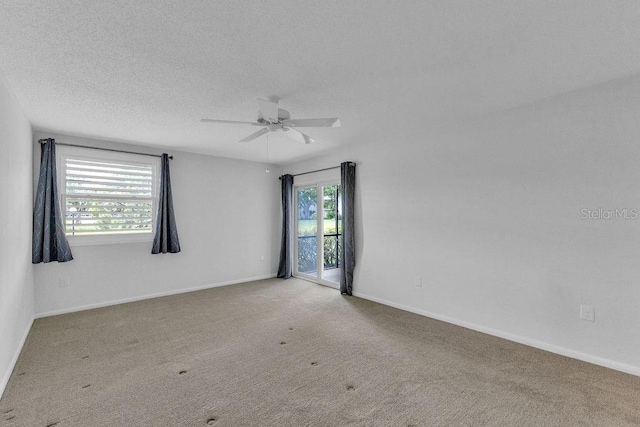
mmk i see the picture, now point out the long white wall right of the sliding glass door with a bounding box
[284,76,640,375]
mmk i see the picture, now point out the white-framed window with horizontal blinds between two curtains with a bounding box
[58,146,160,244]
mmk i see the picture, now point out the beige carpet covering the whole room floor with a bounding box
[0,279,640,427]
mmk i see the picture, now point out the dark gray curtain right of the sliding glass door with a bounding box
[340,162,356,295]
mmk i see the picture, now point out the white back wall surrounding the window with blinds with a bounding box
[34,132,280,316]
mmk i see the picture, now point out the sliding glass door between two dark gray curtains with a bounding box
[295,183,342,287]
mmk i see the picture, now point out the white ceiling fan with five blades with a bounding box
[200,98,341,144]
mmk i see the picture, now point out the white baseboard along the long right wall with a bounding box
[353,292,640,376]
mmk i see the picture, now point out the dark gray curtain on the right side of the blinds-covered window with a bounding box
[151,153,180,254]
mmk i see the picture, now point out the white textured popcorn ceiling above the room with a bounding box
[0,0,640,163]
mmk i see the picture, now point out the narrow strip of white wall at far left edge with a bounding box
[0,72,34,396]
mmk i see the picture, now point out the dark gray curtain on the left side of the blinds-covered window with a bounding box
[31,138,73,264]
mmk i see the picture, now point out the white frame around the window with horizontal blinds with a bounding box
[56,145,160,246]
